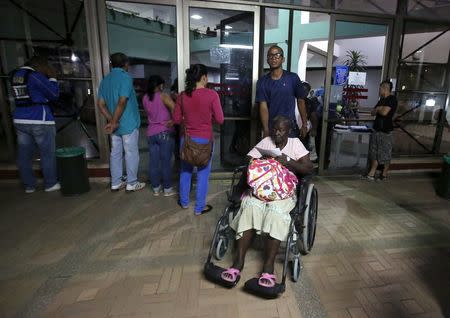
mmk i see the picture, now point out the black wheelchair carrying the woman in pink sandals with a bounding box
[204,166,318,298]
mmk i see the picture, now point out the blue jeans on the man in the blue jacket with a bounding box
[14,124,58,189]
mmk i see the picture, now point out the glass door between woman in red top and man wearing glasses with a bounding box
[184,2,259,171]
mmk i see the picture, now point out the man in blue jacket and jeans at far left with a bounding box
[11,56,61,193]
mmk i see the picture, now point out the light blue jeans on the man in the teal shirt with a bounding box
[109,129,139,186]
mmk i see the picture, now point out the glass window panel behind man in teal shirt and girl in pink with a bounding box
[106,1,178,171]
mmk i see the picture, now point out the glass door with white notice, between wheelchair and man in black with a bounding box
[319,16,392,172]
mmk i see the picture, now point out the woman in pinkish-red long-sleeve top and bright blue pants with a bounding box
[173,64,227,215]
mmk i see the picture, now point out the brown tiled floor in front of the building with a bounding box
[0,176,450,318]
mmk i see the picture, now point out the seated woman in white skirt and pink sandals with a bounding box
[221,116,313,288]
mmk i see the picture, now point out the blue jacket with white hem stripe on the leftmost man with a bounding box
[13,66,59,125]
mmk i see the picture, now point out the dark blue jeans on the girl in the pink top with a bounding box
[147,131,175,189]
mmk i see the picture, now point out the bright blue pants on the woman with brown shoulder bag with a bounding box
[180,137,212,212]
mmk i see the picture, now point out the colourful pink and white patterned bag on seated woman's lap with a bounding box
[247,159,298,201]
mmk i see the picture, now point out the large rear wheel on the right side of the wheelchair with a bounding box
[299,184,318,255]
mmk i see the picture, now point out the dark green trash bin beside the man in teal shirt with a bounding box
[56,147,91,196]
